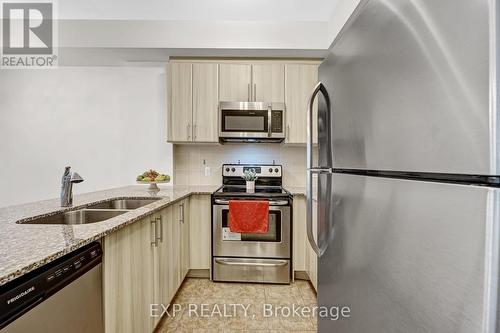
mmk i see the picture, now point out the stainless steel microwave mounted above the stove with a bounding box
[219,102,285,143]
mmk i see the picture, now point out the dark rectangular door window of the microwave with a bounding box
[222,110,267,133]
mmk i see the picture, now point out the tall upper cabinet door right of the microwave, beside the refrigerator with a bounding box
[285,64,318,144]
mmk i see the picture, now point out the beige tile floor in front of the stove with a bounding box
[157,278,317,333]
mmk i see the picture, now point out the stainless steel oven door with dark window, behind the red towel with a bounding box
[212,200,291,258]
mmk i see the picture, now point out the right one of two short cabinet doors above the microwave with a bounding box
[252,64,285,103]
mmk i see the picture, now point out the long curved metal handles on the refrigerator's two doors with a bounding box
[306,82,333,257]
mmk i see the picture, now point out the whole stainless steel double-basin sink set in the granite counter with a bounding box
[17,198,161,225]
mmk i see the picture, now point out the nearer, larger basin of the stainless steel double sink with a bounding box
[20,209,128,224]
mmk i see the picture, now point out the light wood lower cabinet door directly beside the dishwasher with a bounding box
[103,217,155,333]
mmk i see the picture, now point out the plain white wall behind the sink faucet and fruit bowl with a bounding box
[0,67,172,207]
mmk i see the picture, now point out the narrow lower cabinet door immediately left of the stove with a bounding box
[189,195,212,269]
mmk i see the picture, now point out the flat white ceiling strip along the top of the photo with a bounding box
[58,0,338,21]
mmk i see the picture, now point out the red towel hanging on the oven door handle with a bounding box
[229,200,269,234]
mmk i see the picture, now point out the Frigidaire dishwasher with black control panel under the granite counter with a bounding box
[0,243,104,333]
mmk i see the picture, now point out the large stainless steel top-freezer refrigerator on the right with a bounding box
[307,0,500,333]
